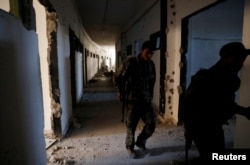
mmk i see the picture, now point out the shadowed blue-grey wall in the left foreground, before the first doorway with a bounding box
[0,10,47,165]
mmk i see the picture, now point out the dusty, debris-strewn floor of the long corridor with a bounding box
[47,72,234,165]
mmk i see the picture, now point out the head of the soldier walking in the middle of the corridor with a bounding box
[141,41,154,61]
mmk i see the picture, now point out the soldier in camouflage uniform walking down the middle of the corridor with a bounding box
[115,41,156,158]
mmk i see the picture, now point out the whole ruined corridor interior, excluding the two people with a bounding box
[0,0,250,165]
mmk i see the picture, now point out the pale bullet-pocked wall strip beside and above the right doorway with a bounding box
[165,0,216,124]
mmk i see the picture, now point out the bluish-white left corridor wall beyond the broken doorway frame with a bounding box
[48,0,107,135]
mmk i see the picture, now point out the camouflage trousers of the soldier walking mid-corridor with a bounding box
[125,102,156,149]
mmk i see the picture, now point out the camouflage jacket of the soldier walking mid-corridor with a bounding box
[114,55,156,102]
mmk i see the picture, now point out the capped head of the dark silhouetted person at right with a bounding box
[220,42,250,70]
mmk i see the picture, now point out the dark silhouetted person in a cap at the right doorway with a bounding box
[183,42,250,163]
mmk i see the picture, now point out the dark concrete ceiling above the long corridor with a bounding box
[74,0,152,46]
